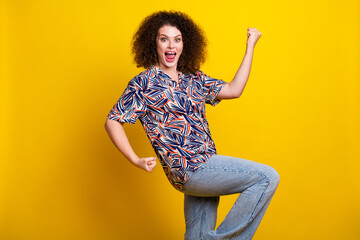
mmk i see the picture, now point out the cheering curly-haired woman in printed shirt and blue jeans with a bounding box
[105,11,279,240]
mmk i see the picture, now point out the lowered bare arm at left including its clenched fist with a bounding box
[105,119,156,172]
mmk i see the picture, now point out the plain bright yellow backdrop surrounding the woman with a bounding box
[0,0,360,240]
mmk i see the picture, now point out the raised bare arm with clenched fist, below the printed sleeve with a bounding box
[216,28,261,100]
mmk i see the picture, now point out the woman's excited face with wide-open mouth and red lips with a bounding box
[156,25,183,70]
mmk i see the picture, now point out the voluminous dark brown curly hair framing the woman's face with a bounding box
[132,11,207,73]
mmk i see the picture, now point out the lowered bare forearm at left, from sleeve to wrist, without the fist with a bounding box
[105,119,139,167]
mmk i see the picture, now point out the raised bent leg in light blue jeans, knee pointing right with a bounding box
[184,155,279,240]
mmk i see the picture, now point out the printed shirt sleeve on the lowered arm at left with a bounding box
[107,77,146,124]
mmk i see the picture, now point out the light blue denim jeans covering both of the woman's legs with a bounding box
[182,155,280,240]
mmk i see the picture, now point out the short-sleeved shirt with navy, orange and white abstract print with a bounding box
[108,66,226,190]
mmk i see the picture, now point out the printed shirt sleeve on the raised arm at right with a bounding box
[199,71,227,106]
